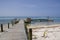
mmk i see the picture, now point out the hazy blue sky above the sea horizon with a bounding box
[0,0,60,17]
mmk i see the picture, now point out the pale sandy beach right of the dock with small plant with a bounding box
[27,24,60,40]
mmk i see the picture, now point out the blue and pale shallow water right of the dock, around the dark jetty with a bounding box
[31,17,60,25]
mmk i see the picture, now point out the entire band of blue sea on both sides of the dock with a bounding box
[0,16,60,24]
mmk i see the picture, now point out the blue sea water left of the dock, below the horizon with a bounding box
[0,16,26,24]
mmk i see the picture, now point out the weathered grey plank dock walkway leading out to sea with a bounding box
[0,20,27,40]
